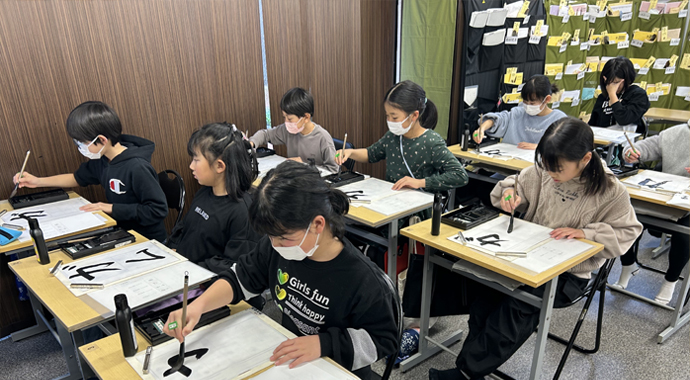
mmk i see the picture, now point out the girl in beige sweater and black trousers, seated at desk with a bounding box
[429,117,642,380]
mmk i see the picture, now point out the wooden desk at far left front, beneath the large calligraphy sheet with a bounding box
[9,231,148,380]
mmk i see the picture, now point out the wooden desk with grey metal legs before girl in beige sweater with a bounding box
[400,220,604,379]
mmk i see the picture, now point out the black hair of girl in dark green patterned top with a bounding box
[383,80,438,129]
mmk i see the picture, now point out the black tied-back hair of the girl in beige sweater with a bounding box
[534,117,613,195]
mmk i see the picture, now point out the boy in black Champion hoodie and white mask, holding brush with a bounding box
[15,102,168,242]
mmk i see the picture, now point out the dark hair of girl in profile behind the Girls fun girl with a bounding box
[187,123,259,201]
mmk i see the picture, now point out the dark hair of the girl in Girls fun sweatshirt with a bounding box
[249,161,350,240]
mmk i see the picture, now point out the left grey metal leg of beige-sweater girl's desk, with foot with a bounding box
[400,246,462,372]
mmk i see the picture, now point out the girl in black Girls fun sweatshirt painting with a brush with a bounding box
[164,161,397,379]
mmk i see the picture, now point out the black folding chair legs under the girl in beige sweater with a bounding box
[549,259,616,379]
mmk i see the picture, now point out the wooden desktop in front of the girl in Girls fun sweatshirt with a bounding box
[79,301,354,380]
